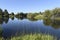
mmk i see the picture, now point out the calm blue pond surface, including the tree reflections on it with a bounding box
[0,18,60,39]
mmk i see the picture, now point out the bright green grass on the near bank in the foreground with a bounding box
[11,34,56,40]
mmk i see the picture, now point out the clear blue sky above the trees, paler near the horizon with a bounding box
[0,0,60,13]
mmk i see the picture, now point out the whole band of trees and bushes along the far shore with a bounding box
[0,8,60,19]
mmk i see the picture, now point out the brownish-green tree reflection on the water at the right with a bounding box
[43,19,60,29]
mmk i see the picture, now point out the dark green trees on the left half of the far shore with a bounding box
[0,8,27,20]
